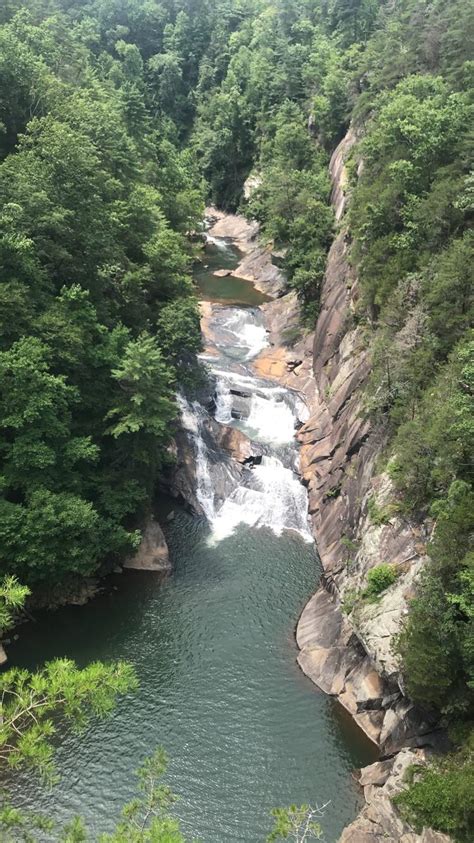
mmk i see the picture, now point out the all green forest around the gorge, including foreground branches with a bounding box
[0,0,474,843]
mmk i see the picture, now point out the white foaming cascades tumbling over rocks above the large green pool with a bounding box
[178,237,313,543]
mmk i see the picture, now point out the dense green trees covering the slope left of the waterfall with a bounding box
[0,2,202,584]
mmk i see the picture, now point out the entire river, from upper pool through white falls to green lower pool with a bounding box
[9,227,376,843]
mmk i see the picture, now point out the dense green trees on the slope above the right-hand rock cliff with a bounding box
[349,0,474,732]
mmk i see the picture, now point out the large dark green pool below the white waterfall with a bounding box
[5,511,375,843]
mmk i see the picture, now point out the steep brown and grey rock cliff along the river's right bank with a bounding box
[250,131,448,843]
